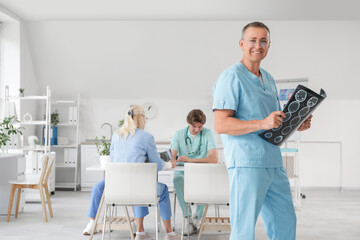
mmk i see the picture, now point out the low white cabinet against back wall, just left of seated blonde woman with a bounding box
[81,144,104,191]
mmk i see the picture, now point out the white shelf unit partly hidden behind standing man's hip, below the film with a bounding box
[280,141,301,210]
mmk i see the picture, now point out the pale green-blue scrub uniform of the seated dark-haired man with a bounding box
[170,127,217,218]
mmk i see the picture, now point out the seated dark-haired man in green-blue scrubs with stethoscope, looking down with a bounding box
[170,109,218,235]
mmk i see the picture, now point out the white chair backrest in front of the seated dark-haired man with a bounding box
[184,163,230,204]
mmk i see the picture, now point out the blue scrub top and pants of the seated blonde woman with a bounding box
[88,128,171,221]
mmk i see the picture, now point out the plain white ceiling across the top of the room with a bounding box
[0,0,360,21]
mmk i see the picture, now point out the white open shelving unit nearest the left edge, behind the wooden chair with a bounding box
[5,86,55,201]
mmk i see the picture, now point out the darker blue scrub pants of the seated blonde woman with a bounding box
[87,180,171,221]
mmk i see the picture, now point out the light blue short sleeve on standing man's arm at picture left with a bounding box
[213,69,241,111]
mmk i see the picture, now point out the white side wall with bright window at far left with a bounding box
[0,5,41,135]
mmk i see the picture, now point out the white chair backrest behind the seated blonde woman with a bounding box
[105,163,157,205]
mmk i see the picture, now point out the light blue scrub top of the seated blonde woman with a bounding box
[110,128,164,171]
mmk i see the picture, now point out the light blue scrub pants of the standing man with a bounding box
[228,167,296,240]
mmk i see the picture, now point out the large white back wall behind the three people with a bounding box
[21,21,360,188]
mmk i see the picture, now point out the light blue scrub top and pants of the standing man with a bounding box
[213,63,296,240]
